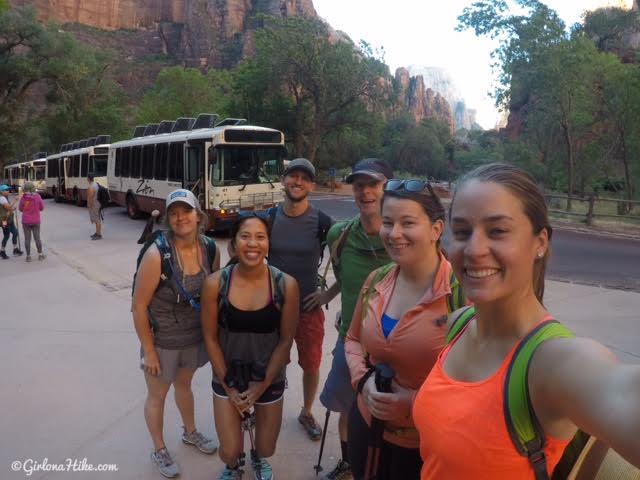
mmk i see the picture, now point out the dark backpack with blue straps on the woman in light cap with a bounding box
[131,230,216,311]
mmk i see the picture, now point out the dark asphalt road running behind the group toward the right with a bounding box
[313,195,640,292]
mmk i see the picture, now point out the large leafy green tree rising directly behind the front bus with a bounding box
[239,17,388,162]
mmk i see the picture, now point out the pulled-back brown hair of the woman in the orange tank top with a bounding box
[449,163,552,303]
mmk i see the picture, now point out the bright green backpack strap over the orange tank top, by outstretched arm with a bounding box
[503,320,573,480]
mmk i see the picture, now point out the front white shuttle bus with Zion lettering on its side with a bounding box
[107,114,286,230]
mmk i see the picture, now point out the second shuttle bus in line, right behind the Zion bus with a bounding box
[46,135,111,206]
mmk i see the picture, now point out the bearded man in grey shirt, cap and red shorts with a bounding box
[269,158,332,440]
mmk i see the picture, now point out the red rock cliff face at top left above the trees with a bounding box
[10,0,317,68]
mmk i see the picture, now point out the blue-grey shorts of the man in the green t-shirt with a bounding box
[320,338,356,415]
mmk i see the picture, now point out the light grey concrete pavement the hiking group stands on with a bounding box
[0,197,640,480]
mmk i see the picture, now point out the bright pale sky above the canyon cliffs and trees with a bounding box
[313,0,632,129]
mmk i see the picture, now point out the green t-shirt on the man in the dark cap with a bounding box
[327,215,391,338]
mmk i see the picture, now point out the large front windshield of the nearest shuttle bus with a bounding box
[209,146,285,186]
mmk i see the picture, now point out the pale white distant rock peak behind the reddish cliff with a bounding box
[408,65,481,130]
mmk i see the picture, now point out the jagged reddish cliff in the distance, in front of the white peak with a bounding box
[395,67,456,134]
